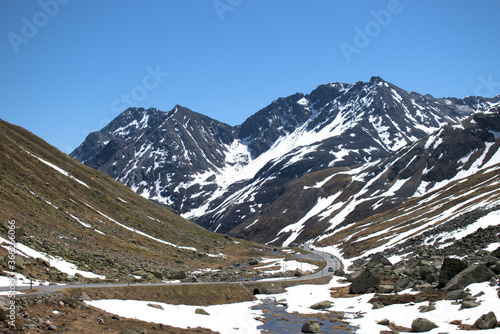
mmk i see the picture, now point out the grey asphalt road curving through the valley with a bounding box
[0,246,341,296]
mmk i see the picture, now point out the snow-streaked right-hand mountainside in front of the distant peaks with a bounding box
[230,106,500,250]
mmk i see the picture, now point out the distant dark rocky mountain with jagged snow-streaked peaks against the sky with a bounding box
[72,77,500,237]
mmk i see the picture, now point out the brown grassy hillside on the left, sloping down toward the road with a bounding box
[0,121,266,276]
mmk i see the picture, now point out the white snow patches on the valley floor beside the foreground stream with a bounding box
[86,277,500,334]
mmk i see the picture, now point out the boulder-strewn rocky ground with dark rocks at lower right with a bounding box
[336,207,500,333]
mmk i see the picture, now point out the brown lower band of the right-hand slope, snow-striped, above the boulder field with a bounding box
[319,166,500,258]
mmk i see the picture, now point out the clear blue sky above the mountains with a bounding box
[0,0,500,153]
